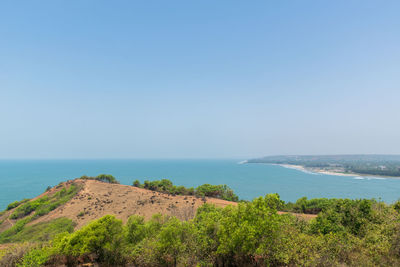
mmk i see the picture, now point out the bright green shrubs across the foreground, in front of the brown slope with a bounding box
[0,194,400,266]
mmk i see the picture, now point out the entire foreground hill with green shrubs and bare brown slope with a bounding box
[0,175,400,266]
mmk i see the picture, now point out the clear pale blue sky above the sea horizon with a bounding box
[0,0,400,159]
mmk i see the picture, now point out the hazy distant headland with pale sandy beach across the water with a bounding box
[246,155,400,177]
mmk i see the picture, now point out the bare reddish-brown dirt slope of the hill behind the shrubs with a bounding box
[31,179,237,228]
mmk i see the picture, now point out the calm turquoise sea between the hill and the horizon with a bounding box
[0,160,400,210]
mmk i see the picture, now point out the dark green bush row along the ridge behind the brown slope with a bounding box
[133,179,239,202]
